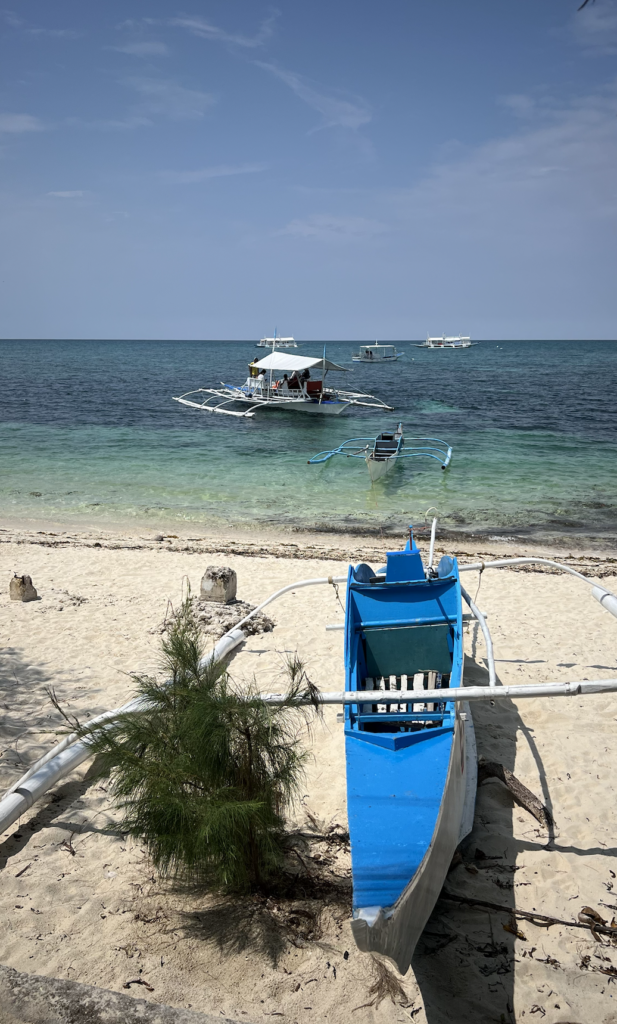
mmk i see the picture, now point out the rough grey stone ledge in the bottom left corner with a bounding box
[0,966,246,1024]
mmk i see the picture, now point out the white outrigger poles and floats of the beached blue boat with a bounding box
[0,519,617,833]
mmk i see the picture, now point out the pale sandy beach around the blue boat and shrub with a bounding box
[0,521,617,1024]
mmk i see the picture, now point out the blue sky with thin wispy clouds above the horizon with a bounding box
[0,0,617,339]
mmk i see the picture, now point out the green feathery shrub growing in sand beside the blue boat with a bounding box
[82,598,316,891]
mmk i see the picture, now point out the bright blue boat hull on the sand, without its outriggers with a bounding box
[345,529,477,974]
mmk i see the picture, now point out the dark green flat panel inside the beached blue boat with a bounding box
[363,623,452,678]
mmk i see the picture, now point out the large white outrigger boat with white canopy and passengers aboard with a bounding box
[174,349,392,417]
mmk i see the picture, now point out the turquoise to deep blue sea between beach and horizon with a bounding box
[0,341,617,544]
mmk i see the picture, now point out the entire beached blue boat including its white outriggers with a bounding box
[0,520,617,972]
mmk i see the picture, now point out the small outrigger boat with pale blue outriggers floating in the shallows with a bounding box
[308,423,452,483]
